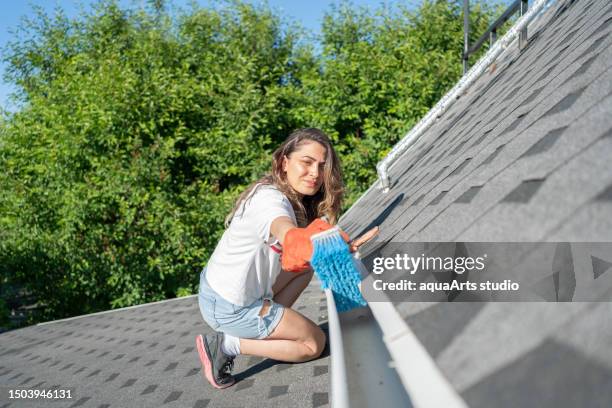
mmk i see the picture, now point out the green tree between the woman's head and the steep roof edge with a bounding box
[296,0,501,205]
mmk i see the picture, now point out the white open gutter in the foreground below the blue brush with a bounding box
[325,252,468,408]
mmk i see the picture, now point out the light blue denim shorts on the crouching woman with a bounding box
[198,268,285,339]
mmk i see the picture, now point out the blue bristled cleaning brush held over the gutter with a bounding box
[310,227,366,312]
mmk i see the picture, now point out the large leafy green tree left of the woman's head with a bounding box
[0,2,302,326]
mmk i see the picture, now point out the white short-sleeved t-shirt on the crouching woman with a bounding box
[206,185,296,306]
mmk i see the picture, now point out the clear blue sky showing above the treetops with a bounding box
[0,0,509,111]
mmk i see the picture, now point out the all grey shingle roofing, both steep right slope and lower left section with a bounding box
[0,0,612,407]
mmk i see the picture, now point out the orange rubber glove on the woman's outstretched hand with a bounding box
[281,218,350,272]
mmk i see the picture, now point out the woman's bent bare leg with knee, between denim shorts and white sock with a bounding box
[240,303,325,363]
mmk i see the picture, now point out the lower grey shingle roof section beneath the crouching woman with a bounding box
[0,281,329,408]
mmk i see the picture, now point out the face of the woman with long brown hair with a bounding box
[283,141,327,195]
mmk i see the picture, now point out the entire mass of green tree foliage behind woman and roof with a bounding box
[0,1,502,326]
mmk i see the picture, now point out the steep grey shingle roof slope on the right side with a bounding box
[341,0,612,407]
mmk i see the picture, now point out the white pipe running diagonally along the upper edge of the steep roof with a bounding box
[376,0,548,193]
